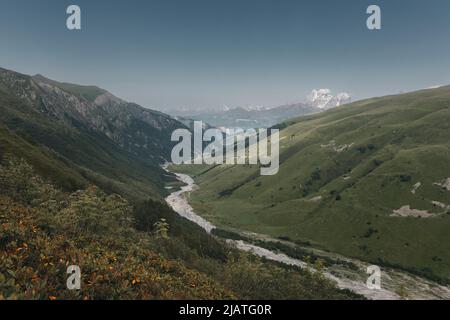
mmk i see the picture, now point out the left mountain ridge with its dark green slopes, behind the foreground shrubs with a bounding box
[0,69,185,197]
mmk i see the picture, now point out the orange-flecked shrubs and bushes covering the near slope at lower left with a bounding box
[0,155,359,300]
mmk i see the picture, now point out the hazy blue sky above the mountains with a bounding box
[0,0,450,109]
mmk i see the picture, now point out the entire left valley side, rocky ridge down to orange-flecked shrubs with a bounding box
[0,69,362,300]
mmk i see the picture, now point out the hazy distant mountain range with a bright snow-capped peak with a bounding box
[171,89,351,129]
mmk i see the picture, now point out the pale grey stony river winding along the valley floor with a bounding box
[163,165,450,300]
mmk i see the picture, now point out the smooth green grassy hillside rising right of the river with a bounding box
[174,87,450,281]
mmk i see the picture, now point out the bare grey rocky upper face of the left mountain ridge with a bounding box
[0,69,184,162]
